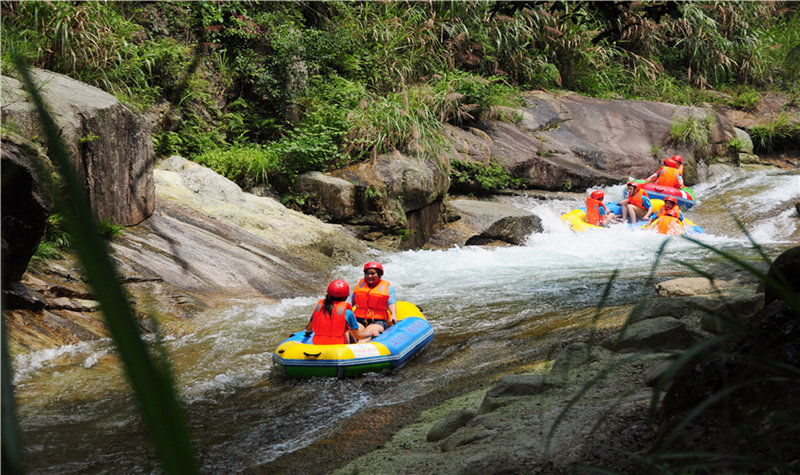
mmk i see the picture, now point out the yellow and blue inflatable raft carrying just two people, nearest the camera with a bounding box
[272,301,433,378]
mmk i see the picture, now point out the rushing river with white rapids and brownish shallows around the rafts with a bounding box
[7,164,800,474]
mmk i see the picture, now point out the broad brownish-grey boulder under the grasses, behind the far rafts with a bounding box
[460,91,736,190]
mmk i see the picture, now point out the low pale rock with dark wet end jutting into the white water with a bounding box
[426,199,542,249]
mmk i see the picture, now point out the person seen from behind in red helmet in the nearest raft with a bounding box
[306,279,380,345]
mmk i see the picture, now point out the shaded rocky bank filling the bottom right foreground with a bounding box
[320,256,800,475]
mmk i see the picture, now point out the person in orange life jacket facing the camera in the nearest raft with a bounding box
[351,261,397,332]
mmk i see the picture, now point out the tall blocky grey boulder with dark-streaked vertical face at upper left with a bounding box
[2,69,155,226]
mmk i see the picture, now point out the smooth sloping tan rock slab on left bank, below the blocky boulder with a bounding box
[4,156,366,353]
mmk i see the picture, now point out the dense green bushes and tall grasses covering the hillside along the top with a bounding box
[2,1,800,190]
